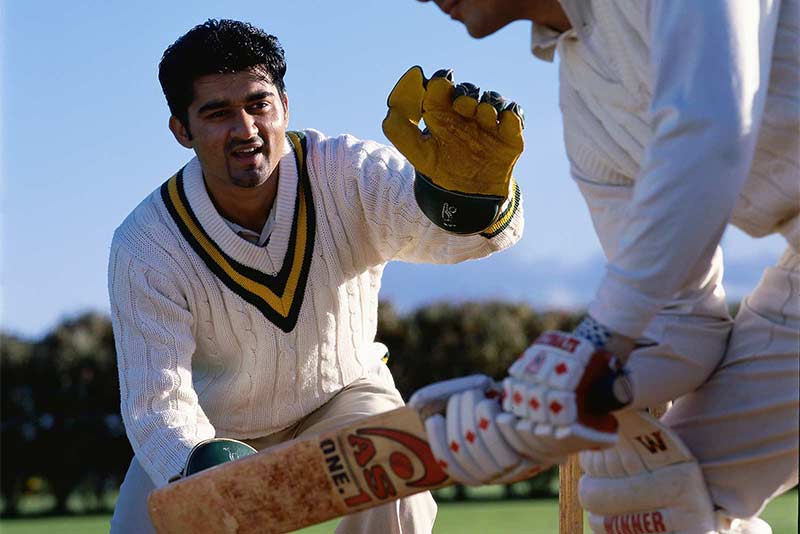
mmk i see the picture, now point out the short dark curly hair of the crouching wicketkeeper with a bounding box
[158,19,286,130]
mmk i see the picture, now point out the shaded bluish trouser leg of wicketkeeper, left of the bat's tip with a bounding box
[111,457,155,534]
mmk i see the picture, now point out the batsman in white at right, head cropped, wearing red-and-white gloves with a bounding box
[419,0,800,532]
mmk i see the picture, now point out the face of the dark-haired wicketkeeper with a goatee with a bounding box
[170,71,289,188]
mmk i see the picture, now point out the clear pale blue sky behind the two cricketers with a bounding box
[0,0,783,337]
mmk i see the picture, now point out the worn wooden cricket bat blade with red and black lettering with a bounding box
[148,407,453,534]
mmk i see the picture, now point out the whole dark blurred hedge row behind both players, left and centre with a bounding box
[0,302,578,515]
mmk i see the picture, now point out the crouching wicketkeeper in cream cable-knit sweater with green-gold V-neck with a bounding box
[109,20,523,534]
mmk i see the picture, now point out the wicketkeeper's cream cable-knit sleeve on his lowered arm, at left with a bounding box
[109,238,214,487]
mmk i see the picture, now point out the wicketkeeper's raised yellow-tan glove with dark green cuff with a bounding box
[383,66,524,234]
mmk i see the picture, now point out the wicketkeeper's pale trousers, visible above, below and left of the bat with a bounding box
[111,366,436,534]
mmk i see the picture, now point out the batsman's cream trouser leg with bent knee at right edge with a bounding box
[664,250,800,518]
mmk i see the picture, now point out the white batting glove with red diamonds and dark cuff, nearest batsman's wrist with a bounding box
[497,331,631,463]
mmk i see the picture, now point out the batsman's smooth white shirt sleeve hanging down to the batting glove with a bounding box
[589,0,779,337]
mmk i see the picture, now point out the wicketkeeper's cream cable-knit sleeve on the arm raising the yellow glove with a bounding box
[318,136,523,264]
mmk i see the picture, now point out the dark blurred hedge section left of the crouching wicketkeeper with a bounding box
[0,313,132,515]
